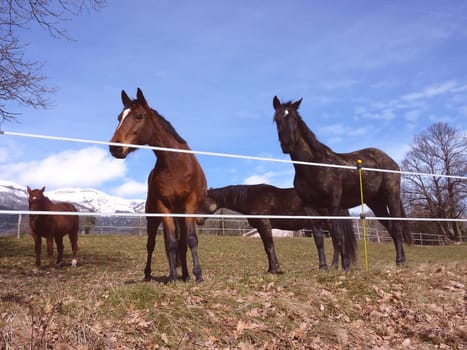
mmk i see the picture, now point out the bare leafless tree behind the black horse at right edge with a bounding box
[402,123,467,241]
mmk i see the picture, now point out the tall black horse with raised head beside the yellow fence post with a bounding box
[273,96,412,268]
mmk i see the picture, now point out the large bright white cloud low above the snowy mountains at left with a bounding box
[0,147,126,188]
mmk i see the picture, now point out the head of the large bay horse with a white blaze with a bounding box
[109,88,153,158]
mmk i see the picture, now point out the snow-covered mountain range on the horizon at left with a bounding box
[0,181,145,213]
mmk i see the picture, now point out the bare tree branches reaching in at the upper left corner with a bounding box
[0,0,105,122]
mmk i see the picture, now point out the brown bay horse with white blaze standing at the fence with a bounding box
[110,88,207,282]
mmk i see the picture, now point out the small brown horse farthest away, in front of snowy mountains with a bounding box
[27,186,79,268]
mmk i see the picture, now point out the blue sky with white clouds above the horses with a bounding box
[0,0,467,198]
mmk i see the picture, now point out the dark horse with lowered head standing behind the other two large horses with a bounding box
[203,184,356,273]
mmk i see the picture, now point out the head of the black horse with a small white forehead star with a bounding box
[272,96,302,153]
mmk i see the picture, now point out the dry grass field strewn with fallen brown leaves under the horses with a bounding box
[0,235,467,349]
